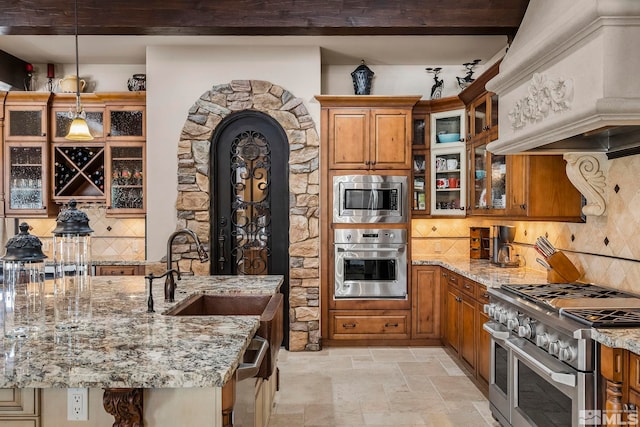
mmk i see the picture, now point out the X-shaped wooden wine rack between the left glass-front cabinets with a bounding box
[53,144,105,200]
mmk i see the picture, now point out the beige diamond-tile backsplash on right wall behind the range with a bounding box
[412,155,640,294]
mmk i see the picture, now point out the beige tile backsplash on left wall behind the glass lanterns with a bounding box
[18,203,146,261]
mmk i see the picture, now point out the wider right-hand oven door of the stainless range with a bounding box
[505,338,595,427]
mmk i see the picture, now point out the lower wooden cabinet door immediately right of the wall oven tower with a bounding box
[411,267,440,338]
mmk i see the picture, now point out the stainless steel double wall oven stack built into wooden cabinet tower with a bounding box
[333,175,408,300]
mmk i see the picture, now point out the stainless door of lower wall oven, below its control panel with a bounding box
[334,244,407,299]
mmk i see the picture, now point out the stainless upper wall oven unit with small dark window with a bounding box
[333,175,408,223]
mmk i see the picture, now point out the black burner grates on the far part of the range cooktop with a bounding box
[502,283,637,304]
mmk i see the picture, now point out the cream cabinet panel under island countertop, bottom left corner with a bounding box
[0,388,40,427]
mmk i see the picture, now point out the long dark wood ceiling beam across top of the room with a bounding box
[0,0,529,37]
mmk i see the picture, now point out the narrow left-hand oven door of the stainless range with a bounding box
[482,322,512,425]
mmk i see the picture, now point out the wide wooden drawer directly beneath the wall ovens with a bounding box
[330,310,411,339]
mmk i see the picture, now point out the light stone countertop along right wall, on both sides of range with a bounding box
[412,257,640,354]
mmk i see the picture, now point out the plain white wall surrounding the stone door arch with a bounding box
[146,46,321,261]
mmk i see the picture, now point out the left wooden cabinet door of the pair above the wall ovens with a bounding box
[329,109,370,169]
